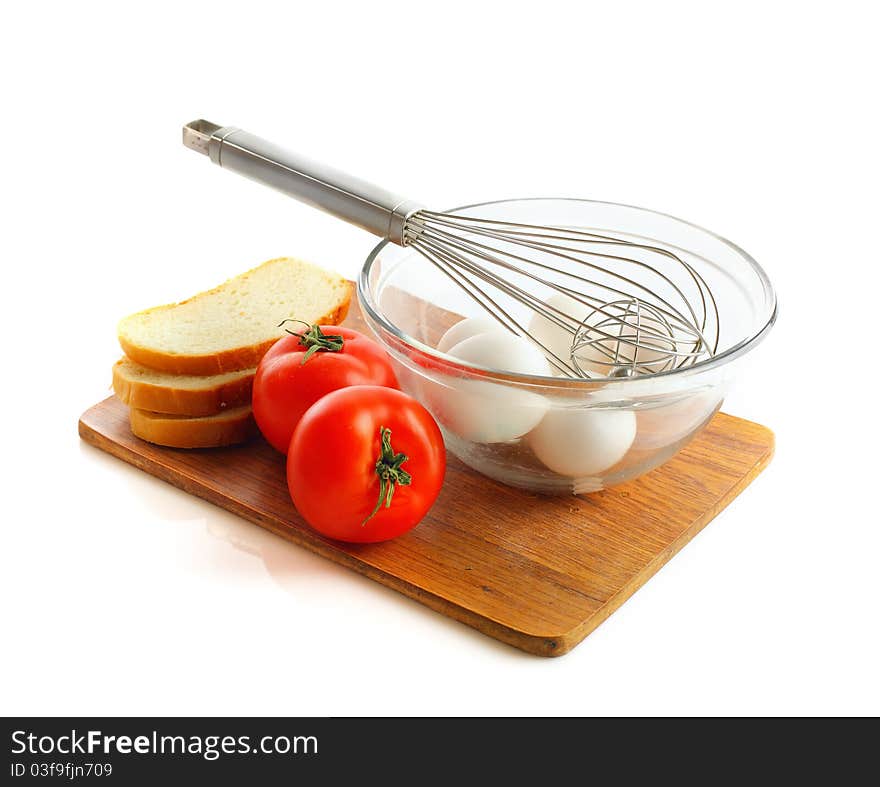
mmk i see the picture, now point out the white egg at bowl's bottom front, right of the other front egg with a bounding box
[528,408,636,478]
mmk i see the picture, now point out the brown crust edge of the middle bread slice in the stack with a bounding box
[113,359,254,416]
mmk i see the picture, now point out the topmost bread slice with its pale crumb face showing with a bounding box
[117,257,352,375]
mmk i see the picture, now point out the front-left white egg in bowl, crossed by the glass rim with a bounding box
[425,332,550,443]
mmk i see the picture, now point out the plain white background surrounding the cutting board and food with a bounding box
[0,0,880,715]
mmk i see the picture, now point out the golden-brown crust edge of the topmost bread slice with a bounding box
[119,282,353,375]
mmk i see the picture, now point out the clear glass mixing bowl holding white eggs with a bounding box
[358,199,776,494]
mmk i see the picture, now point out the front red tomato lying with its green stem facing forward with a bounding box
[287,385,446,542]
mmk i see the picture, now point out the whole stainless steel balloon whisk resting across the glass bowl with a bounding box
[183,120,720,378]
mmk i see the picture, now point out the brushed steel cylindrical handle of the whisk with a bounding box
[183,120,423,245]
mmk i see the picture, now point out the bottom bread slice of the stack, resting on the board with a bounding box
[129,405,257,448]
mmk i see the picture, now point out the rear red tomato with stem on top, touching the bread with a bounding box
[253,325,398,454]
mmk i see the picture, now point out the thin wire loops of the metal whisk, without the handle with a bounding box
[403,210,720,379]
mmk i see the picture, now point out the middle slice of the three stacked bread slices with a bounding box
[113,358,256,416]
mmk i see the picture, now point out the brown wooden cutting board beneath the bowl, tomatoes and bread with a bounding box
[79,304,773,656]
